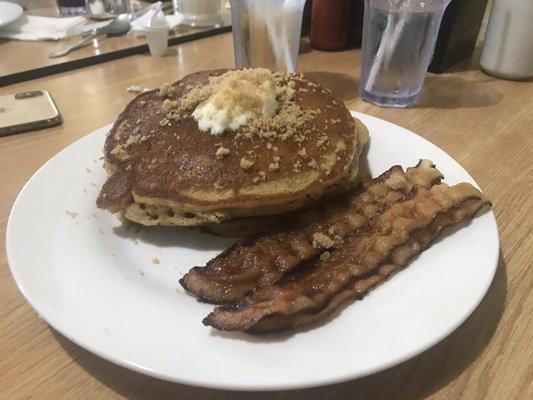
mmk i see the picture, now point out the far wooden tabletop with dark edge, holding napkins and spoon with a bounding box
[0,0,231,86]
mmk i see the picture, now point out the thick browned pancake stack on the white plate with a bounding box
[97,70,368,231]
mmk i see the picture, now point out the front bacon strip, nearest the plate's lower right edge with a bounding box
[203,183,490,332]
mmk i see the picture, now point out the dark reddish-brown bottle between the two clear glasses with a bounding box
[310,0,352,51]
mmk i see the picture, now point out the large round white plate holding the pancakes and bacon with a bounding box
[6,114,499,390]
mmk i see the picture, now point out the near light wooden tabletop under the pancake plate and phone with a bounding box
[0,35,533,400]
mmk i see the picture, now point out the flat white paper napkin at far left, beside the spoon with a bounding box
[0,15,85,41]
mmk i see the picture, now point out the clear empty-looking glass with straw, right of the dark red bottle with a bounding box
[359,0,450,107]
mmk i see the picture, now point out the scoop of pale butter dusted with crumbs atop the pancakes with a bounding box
[192,73,279,135]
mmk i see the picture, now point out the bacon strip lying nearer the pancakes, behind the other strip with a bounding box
[180,160,442,304]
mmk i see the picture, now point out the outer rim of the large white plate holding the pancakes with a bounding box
[5,111,500,392]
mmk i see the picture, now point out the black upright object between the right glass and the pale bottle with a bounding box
[428,0,488,73]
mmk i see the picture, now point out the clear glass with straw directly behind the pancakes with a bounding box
[231,0,305,72]
